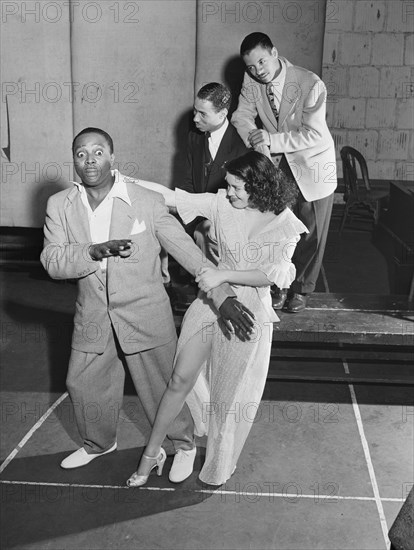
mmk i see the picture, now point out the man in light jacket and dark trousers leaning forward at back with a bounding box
[231,32,337,313]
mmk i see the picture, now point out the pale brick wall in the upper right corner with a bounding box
[322,0,414,180]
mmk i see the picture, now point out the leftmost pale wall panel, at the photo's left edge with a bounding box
[0,0,72,227]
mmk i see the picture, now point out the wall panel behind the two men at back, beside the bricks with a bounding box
[195,0,326,113]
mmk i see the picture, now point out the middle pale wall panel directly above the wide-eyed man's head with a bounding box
[72,0,196,185]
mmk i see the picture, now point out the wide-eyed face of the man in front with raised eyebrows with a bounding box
[73,132,115,187]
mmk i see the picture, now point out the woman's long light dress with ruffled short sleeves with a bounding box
[176,189,307,485]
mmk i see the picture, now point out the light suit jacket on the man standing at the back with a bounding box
[231,57,337,201]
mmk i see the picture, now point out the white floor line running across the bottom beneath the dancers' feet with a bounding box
[0,479,404,503]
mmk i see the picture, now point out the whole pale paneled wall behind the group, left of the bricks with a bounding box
[0,0,326,227]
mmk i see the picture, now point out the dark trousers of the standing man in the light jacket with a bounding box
[279,155,334,294]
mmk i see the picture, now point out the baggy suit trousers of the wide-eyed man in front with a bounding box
[66,331,194,453]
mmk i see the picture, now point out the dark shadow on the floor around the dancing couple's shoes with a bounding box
[1,449,212,548]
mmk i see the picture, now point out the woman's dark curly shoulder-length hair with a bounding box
[225,151,298,214]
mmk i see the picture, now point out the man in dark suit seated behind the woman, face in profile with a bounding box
[177,82,248,262]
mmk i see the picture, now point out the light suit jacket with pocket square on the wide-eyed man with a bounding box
[41,176,235,354]
